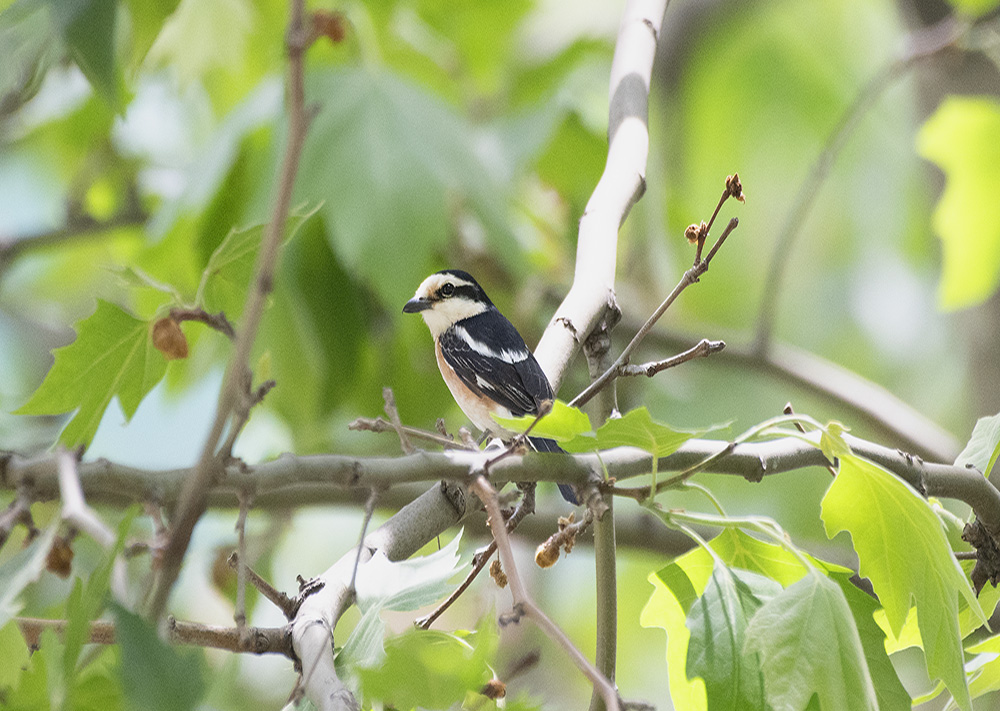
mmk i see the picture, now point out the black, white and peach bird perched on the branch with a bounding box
[403,269,580,505]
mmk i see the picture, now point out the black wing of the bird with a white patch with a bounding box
[438,309,552,417]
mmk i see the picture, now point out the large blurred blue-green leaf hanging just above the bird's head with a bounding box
[296,68,521,309]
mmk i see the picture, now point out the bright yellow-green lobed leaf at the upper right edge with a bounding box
[917,97,1000,310]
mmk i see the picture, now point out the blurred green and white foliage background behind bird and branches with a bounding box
[0,0,1000,708]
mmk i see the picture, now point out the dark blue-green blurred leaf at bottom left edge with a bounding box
[111,604,205,711]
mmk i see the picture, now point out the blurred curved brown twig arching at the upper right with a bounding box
[754,15,969,353]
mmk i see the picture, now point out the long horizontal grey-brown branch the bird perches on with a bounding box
[0,435,1000,528]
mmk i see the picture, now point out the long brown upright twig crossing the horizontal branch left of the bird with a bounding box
[149,0,308,620]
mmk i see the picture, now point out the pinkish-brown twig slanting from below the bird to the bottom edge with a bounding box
[469,474,619,711]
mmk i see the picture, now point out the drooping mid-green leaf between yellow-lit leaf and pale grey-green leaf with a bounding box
[687,563,781,709]
